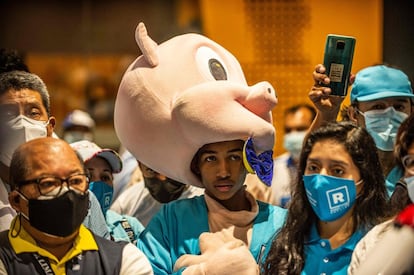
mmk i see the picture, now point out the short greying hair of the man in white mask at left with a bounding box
[0,71,50,116]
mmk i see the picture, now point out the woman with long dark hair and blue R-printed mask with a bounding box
[263,122,389,274]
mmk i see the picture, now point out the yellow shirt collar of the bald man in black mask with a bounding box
[9,216,98,275]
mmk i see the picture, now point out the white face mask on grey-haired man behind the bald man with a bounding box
[0,115,49,166]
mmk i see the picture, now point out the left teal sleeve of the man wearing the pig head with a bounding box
[138,196,209,274]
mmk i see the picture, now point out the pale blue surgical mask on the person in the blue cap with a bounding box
[359,107,408,151]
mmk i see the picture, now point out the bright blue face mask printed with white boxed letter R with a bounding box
[303,174,361,222]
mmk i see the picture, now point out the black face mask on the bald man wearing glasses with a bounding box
[20,190,89,237]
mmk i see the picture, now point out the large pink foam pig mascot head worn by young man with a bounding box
[114,23,277,187]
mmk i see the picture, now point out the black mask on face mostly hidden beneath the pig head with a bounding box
[144,177,187,203]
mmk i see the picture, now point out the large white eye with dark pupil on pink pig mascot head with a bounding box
[196,46,227,80]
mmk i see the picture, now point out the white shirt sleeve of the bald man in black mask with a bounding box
[119,243,154,275]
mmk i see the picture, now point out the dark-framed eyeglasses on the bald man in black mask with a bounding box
[19,174,89,197]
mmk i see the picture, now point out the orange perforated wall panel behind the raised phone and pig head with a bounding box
[200,0,382,155]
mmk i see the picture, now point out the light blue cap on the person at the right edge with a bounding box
[351,65,414,102]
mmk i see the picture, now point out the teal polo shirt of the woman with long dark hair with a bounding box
[301,224,366,275]
